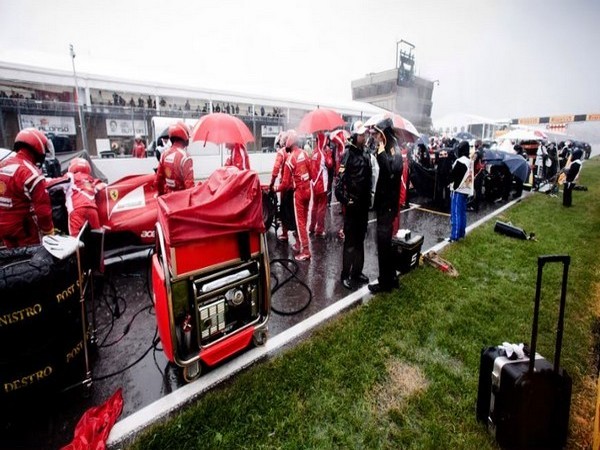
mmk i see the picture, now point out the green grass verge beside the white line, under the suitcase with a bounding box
[131,158,600,450]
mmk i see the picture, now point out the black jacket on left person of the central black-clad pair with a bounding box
[335,143,373,207]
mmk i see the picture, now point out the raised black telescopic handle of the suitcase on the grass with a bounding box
[529,255,571,374]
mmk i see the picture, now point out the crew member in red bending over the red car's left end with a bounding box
[48,158,106,236]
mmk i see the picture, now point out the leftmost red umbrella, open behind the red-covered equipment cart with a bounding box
[190,113,254,145]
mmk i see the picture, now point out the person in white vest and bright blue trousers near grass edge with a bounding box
[450,141,473,242]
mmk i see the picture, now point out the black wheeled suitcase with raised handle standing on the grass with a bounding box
[477,255,572,450]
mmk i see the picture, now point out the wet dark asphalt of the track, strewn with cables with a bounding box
[0,192,504,449]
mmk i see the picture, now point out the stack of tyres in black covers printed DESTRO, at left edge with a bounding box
[0,246,87,410]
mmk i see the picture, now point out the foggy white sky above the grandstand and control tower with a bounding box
[0,0,600,119]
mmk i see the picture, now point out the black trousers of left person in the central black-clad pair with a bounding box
[341,203,369,280]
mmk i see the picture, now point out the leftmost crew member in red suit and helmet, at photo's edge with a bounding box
[0,128,54,248]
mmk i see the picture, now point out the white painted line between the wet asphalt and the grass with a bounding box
[107,195,520,449]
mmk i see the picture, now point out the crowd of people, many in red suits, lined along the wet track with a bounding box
[0,122,584,292]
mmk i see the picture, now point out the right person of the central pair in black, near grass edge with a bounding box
[369,118,402,293]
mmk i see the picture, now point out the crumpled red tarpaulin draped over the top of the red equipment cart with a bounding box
[158,167,265,246]
